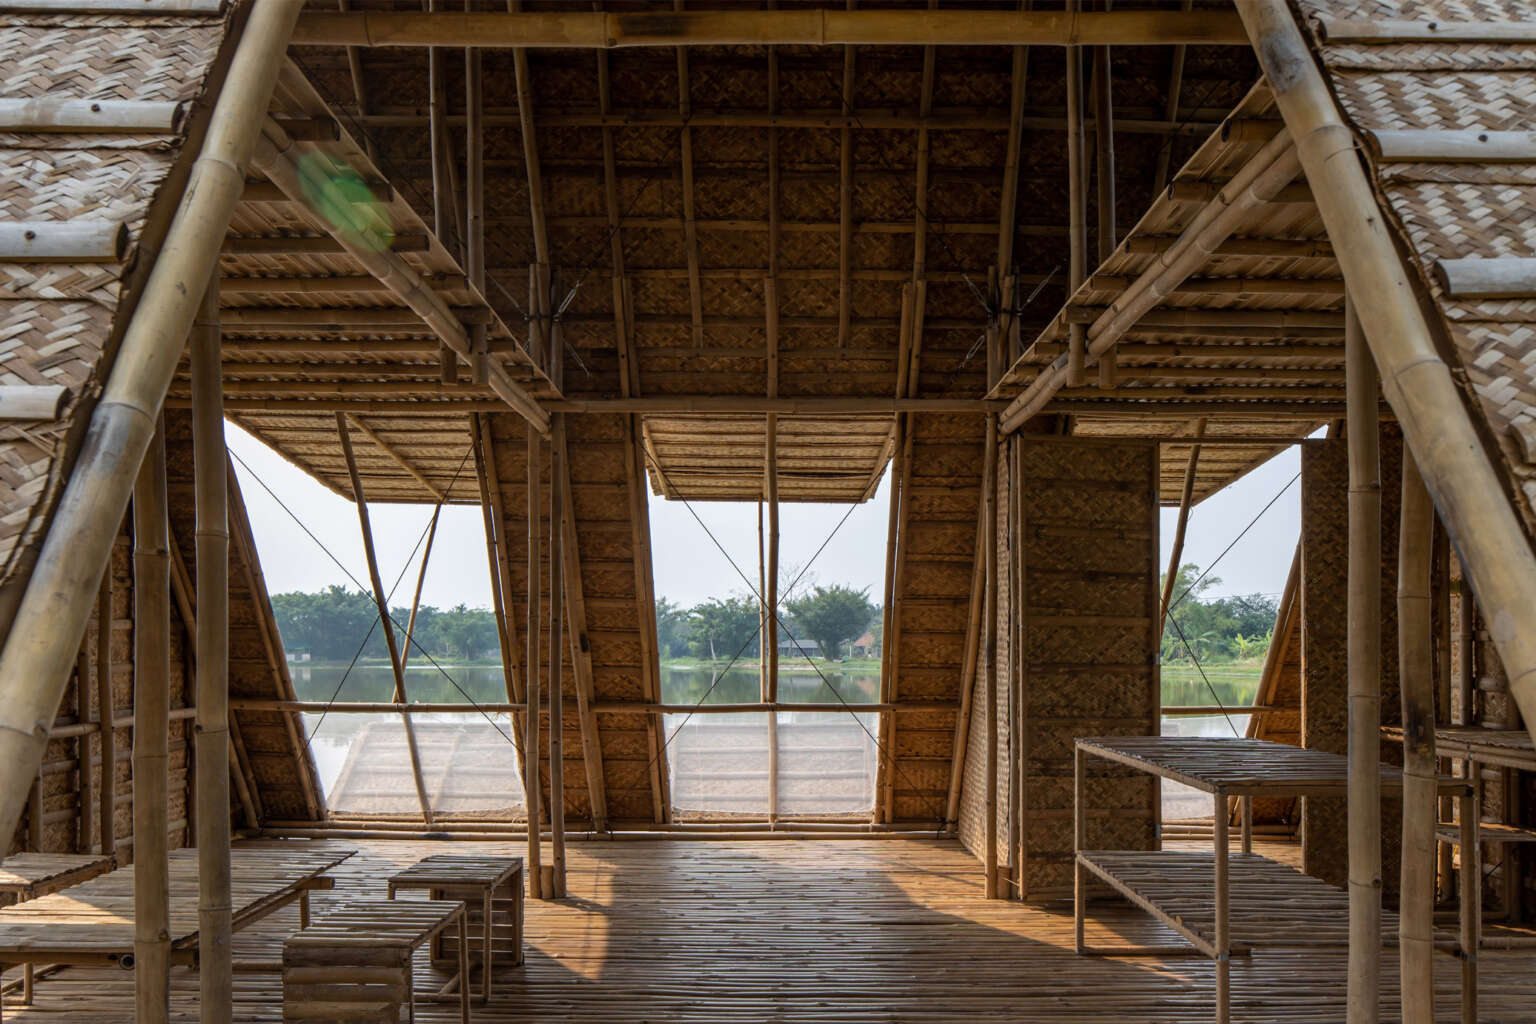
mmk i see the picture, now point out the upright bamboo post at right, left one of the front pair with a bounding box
[1344,299,1381,1024]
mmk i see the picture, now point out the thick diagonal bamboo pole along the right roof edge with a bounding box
[1238,0,1536,752]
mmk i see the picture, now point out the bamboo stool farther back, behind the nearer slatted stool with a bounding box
[389,854,522,1003]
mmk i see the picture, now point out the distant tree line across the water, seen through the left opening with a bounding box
[272,585,501,662]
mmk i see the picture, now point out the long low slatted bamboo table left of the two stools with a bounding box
[0,843,356,1019]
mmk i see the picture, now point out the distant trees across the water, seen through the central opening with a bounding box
[656,583,883,662]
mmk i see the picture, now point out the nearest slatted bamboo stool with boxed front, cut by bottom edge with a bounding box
[283,900,470,1024]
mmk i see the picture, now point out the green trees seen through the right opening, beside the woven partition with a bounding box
[1161,562,1279,663]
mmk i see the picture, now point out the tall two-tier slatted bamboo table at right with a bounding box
[1072,735,1479,1024]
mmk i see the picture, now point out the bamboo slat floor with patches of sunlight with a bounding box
[6,838,1536,1024]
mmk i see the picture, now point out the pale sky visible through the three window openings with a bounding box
[227,424,1301,608]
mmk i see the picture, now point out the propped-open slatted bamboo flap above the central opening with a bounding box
[642,416,895,502]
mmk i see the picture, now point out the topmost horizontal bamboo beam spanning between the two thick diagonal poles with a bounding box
[293,8,1247,49]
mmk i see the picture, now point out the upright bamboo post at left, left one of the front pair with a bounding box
[134,424,170,1024]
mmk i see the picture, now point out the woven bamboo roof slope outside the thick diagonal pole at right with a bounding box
[1303,0,1536,536]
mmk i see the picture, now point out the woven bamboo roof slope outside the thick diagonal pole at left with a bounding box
[0,14,224,606]
